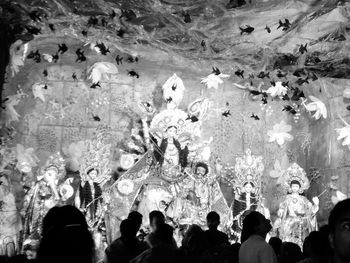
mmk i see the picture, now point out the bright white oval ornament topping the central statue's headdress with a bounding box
[162,74,185,108]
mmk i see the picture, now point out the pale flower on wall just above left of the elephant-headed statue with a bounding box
[16,144,39,173]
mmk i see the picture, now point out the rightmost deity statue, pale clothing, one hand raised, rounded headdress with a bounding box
[274,163,319,247]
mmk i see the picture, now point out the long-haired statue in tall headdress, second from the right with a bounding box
[232,149,269,240]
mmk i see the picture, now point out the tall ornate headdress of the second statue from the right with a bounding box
[233,149,264,190]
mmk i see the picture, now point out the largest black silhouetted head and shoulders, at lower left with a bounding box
[38,205,95,263]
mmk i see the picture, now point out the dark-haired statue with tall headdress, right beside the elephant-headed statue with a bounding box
[75,127,111,259]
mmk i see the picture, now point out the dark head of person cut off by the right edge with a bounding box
[328,199,350,263]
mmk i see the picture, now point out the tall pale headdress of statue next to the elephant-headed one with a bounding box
[80,130,111,184]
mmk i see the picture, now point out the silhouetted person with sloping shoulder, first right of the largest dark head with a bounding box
[105,219,149,263]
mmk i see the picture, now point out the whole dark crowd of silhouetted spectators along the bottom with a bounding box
[0,199,350,263]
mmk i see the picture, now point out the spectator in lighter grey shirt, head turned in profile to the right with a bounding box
[239,211,277,263]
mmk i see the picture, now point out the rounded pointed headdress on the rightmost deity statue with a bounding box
[282,163,310,193]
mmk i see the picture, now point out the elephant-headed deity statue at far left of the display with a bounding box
[23,153,65,245]
